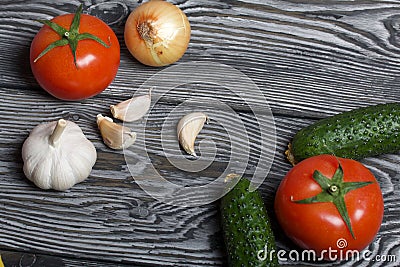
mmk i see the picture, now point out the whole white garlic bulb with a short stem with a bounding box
[22,119,97,191]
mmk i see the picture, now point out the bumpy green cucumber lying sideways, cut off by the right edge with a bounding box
[286,103,400,165]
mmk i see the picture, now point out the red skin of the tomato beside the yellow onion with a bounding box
[30,8,120,100]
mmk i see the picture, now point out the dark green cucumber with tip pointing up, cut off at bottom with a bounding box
[221,178,279,266]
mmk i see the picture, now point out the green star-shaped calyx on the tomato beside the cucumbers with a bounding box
[294,163,373,239]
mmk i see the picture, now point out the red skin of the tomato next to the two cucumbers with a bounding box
[275,155,384,260]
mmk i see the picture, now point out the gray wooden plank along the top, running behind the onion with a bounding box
[0,1,399,116]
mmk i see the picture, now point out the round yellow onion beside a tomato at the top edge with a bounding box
[124,0,190,67]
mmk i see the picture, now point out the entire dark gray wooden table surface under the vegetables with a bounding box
[0,0,400,266]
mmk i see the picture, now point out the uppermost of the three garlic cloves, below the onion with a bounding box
[110,89,151,122]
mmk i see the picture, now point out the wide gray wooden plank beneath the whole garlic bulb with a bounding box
[0,92,399,266]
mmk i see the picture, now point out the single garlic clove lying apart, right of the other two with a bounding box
[177,112,208,157]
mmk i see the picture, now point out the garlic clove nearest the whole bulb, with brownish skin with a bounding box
[97,114,136,149]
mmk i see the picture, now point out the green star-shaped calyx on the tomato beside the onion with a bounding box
[33,4,110,66]
